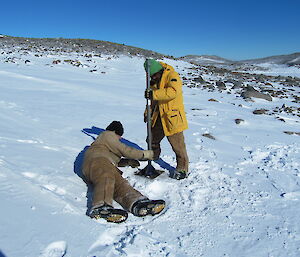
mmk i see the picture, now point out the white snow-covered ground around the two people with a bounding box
[0,50,300,257]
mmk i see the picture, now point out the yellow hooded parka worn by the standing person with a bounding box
[151,62,188,136]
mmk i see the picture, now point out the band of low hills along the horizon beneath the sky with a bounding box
[0,34,300,66]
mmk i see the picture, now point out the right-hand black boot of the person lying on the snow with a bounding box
[131,199,166,217]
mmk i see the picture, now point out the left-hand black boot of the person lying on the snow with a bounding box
[89,204,128,223]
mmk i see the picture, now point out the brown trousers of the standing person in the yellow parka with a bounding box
[151,116,189,172]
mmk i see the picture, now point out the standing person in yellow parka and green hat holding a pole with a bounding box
[144,59,189,180]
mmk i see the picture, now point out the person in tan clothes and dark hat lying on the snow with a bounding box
[82,121,165,223]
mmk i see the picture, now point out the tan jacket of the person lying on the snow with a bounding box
[82,131,144,175]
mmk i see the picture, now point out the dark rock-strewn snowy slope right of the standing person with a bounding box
[183,61,300,122]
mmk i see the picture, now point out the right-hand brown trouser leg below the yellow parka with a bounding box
[167,132,189,173]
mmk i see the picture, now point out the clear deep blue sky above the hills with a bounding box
[0,0,300,60]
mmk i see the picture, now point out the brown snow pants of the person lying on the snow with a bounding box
[83,157,146,211]
